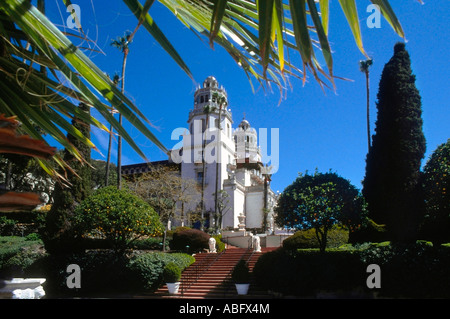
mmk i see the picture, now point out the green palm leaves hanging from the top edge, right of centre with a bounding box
[202,0,404,87]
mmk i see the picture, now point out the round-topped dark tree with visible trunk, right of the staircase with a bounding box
[275,172,365,252]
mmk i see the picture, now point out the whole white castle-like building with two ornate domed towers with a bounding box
[122,76,276,232]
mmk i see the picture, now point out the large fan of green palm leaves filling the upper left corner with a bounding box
[0,0,167,180]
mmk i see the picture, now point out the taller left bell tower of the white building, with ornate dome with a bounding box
[181,76,235,225]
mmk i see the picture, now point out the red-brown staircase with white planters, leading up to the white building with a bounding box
[155,247,275,299]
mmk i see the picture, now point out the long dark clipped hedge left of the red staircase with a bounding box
[40,250,195,298]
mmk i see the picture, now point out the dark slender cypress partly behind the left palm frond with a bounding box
[43,103,91,252]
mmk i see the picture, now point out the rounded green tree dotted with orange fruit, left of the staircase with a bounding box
[70,186,164,250]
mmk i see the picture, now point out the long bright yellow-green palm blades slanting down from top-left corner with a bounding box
[0,0,167,158]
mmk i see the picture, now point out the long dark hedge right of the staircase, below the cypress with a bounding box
[253,241,450,298]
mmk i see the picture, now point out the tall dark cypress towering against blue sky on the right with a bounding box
[363,43,426,241]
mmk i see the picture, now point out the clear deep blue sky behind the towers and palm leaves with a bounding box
[47,0,450,195]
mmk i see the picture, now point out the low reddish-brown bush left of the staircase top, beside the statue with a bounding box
[170,229,211,252]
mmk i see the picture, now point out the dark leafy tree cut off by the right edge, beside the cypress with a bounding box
[423,139,450,243]
